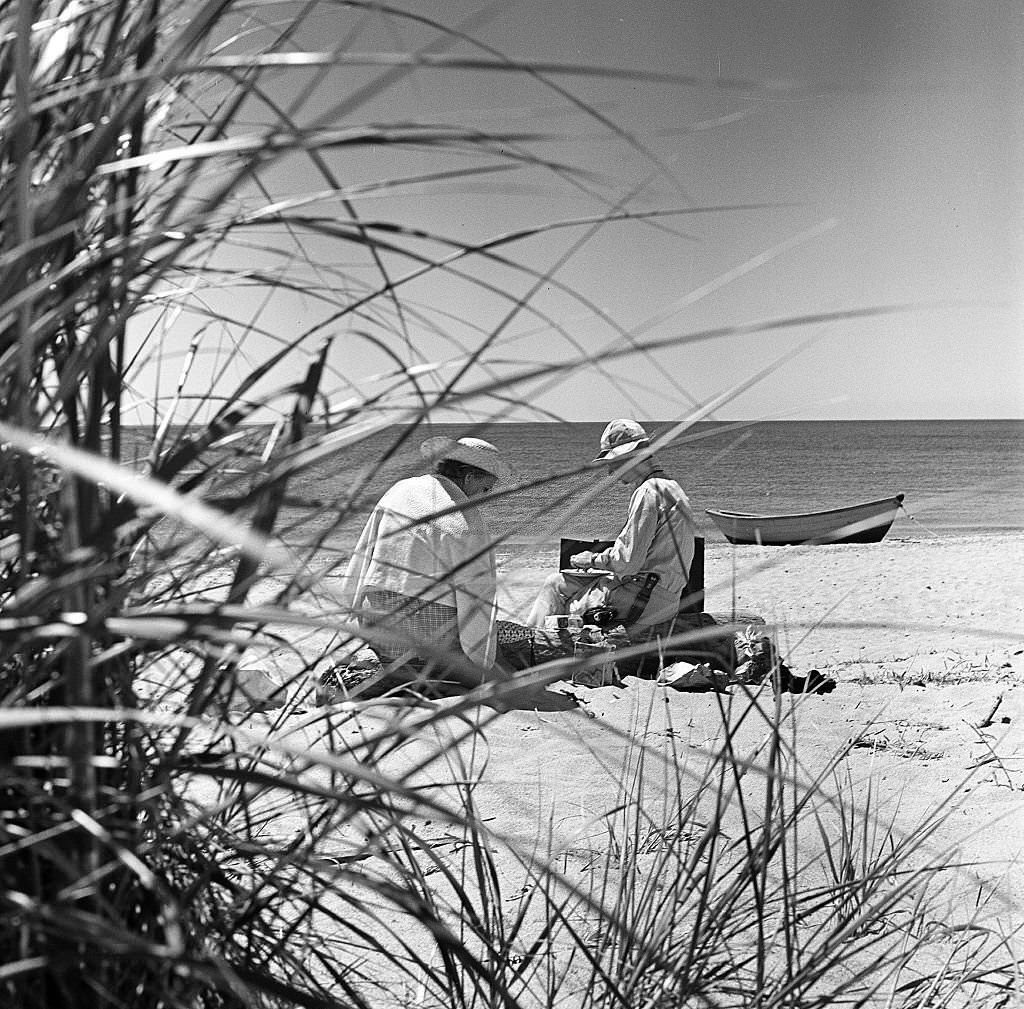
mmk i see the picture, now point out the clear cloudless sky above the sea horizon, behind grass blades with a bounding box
[138,0,1024,420]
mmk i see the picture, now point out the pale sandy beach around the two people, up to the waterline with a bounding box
[193,534,1024,1005]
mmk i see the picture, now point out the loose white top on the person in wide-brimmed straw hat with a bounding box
[341,473,498,667]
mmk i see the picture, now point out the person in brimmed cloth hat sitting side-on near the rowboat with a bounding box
[527,419,696,639]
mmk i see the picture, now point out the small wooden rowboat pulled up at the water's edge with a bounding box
[706,494,903,546]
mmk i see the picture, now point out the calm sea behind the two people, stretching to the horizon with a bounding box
[272,420,1024,555]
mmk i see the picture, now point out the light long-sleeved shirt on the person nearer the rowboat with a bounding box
[593,476,696,624]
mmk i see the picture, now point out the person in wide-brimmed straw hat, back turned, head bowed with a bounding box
[342,437,511,675]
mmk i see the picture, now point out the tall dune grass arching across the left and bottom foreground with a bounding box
[0,0,1017,1009]
